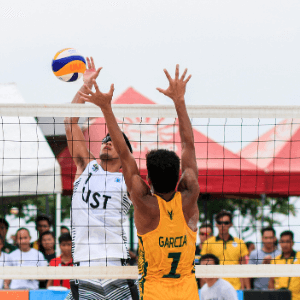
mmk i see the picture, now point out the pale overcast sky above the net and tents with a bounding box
[0,0,300,246]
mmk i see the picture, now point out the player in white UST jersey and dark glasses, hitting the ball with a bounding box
[65,58,138,300]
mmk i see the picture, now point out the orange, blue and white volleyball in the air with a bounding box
[52,48,86,82]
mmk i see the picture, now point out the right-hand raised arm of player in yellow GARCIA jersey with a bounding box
[157,65,199,200]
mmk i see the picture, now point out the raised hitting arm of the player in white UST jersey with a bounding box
[64,57,101,175]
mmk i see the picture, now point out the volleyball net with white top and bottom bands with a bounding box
[0,104,300,279]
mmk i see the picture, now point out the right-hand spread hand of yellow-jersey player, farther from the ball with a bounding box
[157,65,192,103]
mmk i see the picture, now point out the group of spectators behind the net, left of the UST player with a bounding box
[0,215,73,290]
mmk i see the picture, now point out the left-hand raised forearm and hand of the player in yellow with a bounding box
[80,80,140,194]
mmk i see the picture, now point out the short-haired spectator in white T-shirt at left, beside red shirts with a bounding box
[4,227,47,290]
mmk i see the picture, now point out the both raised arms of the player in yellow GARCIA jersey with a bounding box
[80,66,199,234]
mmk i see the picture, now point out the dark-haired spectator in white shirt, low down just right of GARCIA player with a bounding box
[200,254,238,300]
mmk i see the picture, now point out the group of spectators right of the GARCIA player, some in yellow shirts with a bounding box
[195,211,300,300]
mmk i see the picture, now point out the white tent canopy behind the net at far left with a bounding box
[0,83,62,197]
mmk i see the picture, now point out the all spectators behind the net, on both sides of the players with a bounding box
[0,211,300,300]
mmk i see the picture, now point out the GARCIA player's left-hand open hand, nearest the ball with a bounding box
[79,79,115,108]
